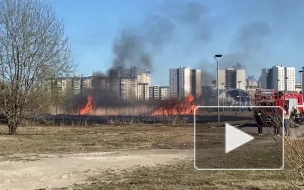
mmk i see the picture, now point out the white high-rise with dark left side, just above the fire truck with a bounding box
[261,66,296,92]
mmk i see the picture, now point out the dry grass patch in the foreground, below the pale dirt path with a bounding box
[75,160,294,190]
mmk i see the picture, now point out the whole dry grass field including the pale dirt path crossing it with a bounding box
[0,121,300,190]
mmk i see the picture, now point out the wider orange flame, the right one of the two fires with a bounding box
[152,95,197,116]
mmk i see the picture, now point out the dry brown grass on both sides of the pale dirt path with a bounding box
[0,122,300,190]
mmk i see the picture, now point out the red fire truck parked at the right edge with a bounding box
[253,89,304,125]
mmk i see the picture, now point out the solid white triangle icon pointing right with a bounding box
[225,123,254,153]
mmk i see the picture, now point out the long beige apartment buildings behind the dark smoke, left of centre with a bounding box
[48,67,151,100]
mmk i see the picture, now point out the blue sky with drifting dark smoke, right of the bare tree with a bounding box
[49,0,304,85]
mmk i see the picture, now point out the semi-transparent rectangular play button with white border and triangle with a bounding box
[194,106,284,170]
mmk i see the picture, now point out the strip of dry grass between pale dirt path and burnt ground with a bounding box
[0,121,247,154]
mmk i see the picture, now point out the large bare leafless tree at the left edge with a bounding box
[0,0,75,135]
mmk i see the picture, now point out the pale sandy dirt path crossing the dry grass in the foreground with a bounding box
[0,150,193,190]
